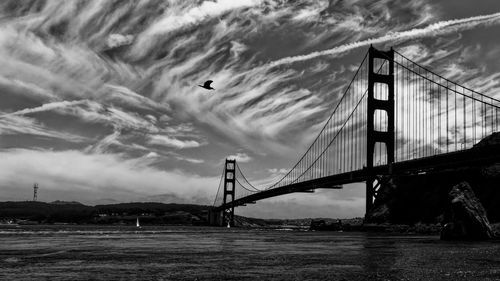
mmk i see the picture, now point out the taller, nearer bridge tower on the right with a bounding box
[366,46,395,213]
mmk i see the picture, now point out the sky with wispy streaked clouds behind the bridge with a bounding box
[0,0,500,218]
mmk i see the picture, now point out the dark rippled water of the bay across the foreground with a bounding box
[0,226,500,280]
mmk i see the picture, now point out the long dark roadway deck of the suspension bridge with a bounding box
[214,144,500,211]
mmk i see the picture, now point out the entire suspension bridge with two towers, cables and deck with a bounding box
[209,46,500,225]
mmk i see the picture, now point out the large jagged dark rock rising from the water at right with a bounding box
[441,182,494,240]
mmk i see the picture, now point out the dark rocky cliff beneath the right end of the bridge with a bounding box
[366,133,500,228]
